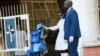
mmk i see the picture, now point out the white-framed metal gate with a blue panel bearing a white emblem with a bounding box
[0,14,30,52]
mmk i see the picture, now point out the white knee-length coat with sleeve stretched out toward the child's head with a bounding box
[49,19,68,50]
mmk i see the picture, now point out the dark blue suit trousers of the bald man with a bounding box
[68,37,79,56]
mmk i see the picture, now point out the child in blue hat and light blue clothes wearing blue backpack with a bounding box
[31,23,46,56]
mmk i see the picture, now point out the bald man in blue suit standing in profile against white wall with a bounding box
[64,0,81,56]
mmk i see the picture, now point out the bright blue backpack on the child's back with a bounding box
[30,30,41,44]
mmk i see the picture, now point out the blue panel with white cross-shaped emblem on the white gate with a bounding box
[4,18,16,49]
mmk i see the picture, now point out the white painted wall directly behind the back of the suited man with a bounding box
[72,0,98,56]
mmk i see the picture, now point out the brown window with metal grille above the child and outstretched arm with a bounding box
[21,0,59,30]
